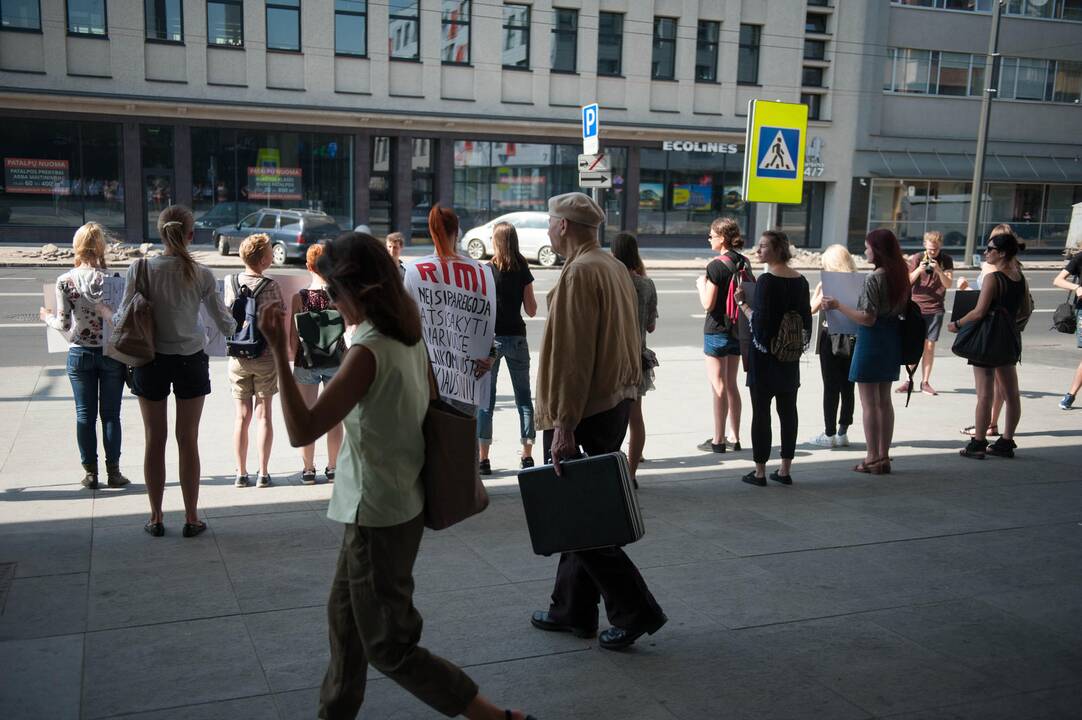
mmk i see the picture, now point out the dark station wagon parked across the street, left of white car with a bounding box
[214,208,342,265]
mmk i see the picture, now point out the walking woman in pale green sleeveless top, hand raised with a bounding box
[260,233,528,720]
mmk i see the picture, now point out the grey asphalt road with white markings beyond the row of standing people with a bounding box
[0,267,1080,368]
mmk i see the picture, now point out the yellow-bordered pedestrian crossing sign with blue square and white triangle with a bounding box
[743,100,808,204]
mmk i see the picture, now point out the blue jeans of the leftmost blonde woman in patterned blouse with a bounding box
[67,345,124,466]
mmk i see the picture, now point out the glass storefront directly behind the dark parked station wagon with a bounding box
[192,128,353,228]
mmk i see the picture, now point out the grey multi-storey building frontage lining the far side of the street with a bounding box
[0,0,1082,247]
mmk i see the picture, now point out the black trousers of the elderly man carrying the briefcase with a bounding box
[542,401,664,629]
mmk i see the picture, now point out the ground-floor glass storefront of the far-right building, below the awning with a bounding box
[868,178,1082,249]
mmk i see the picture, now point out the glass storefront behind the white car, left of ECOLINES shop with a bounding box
[454,140,628,234]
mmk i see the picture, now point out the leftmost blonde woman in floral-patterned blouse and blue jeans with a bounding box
[40,223,129,489]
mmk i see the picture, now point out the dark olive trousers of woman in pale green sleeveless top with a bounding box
[318,514,477,720]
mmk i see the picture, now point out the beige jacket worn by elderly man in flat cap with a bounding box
[535,246,643,430]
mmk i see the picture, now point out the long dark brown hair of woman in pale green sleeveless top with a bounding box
[316,233,421,346]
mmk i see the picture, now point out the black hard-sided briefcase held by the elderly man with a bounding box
[518,453,646,555]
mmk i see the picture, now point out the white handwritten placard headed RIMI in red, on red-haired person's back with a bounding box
[406,256,496,406]
